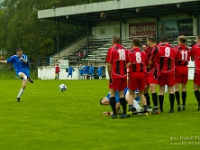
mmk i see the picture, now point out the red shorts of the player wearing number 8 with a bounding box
[128,72,146,91]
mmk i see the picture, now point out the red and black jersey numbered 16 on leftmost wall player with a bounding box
[106,44,128,78]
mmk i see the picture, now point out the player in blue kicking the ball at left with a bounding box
[0,48,33,102]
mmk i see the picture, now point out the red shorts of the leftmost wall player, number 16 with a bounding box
[109,78,127,91]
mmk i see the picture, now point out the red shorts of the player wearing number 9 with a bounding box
[158,73,175,86]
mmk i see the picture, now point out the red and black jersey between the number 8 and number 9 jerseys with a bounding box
[146,45,160,76]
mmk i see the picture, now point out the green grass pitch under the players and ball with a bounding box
[0,79,200,150]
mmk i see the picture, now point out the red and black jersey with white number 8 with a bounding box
[128,48,147,73]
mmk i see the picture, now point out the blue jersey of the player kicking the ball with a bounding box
[7,54,30,77]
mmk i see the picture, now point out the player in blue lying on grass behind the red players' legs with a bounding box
[100,88,143,115]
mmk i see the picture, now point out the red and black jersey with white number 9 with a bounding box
[159,44,176,74]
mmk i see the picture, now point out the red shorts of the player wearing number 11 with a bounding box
[175,66,188,84]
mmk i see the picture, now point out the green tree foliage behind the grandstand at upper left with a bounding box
[0,0,107,60]
